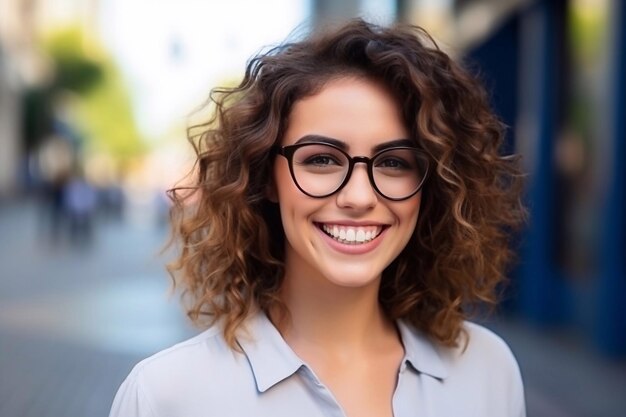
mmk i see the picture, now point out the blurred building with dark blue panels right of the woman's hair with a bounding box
[312,0,626,356]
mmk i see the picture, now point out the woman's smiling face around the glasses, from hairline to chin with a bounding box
[274,78,421,287]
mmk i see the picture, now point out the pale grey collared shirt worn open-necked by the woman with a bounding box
[110,313,526,417]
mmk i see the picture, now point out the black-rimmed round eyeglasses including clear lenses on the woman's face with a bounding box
[275,142,428,201]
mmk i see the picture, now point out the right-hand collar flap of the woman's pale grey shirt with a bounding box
[397,320,449,379]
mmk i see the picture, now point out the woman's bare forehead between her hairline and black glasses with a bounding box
[281,78,408,149]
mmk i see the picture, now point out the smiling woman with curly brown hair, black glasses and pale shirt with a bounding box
[111,20,525,417]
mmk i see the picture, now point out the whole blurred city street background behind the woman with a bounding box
[0,0,626,417]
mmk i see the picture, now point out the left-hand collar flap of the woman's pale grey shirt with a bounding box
[237,312,304,392]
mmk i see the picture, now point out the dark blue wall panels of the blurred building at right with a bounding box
[467,0,626,356]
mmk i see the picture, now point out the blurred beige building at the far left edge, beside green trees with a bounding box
[0,0,98,199]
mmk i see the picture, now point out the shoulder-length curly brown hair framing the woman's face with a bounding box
[168,19,525,348]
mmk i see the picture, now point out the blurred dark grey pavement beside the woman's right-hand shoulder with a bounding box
[489,319,626,417]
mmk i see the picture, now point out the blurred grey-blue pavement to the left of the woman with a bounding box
[0,199,193,417]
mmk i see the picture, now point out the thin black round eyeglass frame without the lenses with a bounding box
[273,142,430,201]
